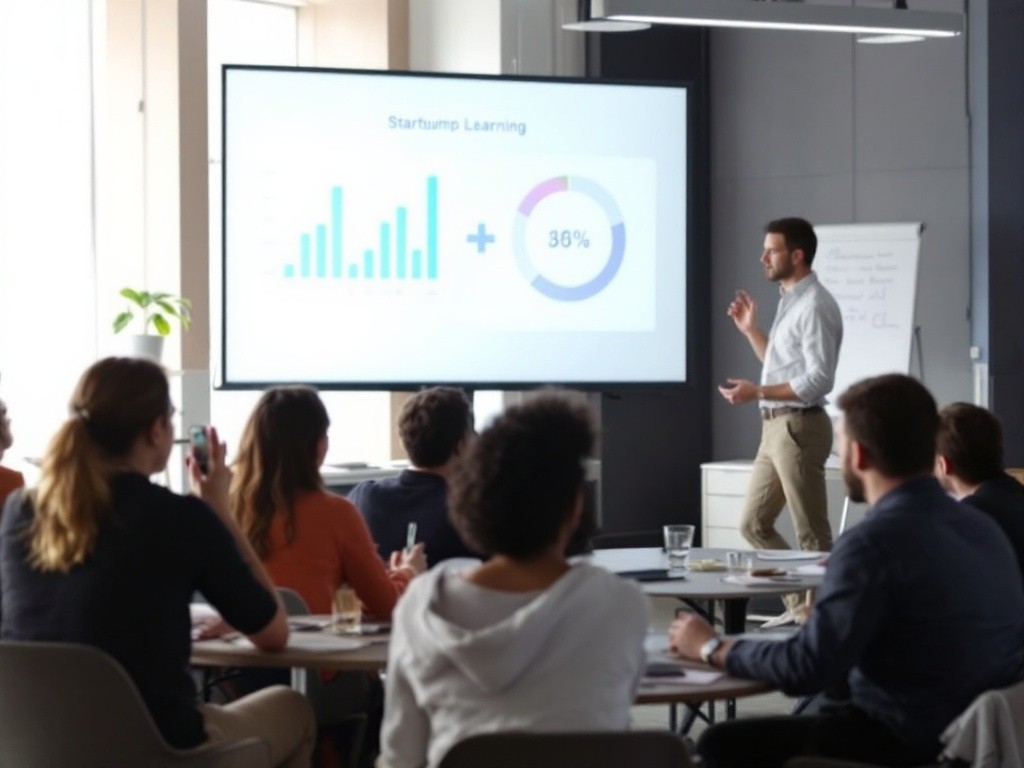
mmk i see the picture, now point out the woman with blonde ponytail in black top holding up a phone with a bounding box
[0,357,315,768]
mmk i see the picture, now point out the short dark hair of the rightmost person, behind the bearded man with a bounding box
[936,402,1002,484]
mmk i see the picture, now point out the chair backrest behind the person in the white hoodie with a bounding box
[438,731,690,768]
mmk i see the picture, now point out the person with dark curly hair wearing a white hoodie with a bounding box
[380,396,649,768]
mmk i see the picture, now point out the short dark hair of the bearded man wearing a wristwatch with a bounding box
[839,374,939,477]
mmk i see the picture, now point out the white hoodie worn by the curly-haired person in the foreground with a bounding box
[380,563,650,768]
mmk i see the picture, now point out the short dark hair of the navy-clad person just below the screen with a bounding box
[398,387,473,467]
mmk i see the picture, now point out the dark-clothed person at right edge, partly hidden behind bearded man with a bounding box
[936,402,1024,578]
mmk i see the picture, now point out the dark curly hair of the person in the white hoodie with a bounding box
[449,395,594,560]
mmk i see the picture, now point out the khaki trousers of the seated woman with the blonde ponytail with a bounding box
[199,685,316,768]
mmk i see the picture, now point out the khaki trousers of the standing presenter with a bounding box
[739,411,833,609]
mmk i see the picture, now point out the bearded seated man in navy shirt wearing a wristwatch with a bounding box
[669,375,1024,768]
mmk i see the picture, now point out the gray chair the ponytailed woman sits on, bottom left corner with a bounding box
[0,641,270,768]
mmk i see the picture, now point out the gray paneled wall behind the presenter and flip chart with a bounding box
[710,28,972,459]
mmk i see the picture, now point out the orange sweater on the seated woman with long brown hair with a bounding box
[263,492,412,620]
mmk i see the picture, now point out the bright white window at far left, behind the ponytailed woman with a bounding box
[0,0,97,470]
